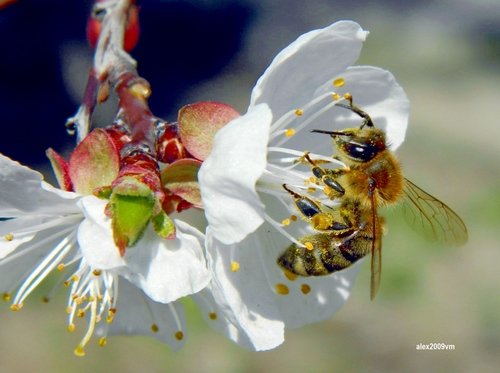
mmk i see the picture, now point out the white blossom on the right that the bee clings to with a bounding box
[199,21,409,350]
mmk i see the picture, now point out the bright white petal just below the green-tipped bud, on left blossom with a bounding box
[122,220,210,303]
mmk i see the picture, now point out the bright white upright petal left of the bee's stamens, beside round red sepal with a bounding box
[198,104,272,243]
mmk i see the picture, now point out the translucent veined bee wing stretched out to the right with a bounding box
[403,179,468,246]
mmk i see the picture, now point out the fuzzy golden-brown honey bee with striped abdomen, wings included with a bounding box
[277,101,467,299]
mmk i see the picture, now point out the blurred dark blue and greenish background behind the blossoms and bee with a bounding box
[0,0,500,372]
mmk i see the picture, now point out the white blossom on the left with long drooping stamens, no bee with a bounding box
[0,155,210,355]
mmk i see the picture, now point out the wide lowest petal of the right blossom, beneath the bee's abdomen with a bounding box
[207,224,359,350]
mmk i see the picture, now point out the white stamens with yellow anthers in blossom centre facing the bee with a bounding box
[257,88,352,248]
